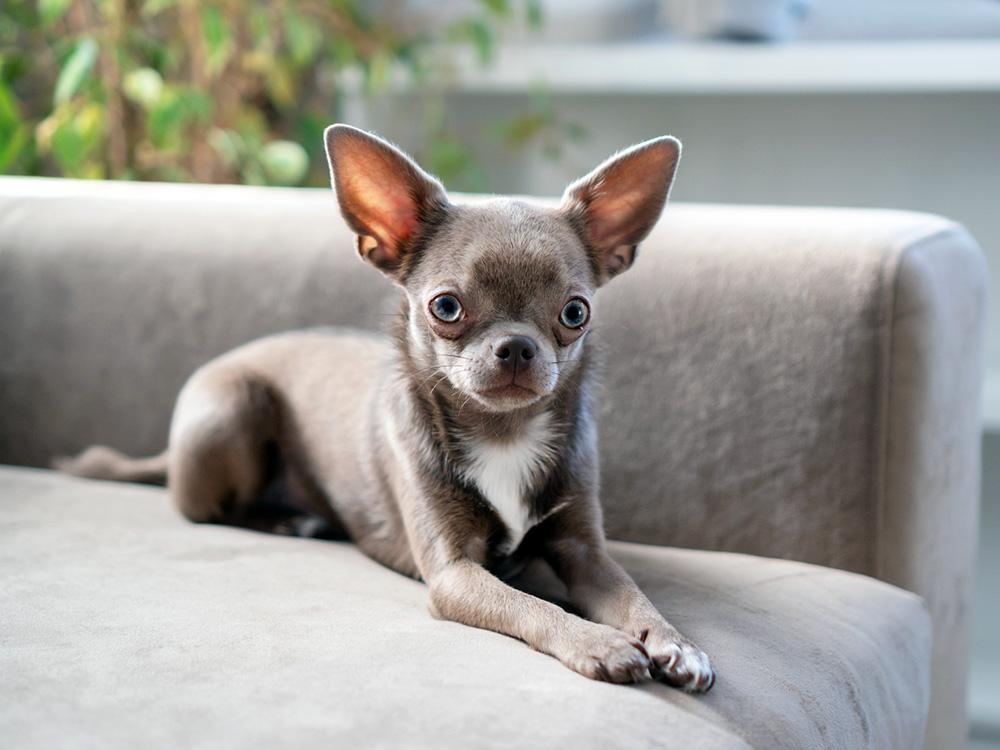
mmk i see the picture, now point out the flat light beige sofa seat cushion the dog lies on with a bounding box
[0,467,930,749]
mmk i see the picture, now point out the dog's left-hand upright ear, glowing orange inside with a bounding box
[324,125,448,276]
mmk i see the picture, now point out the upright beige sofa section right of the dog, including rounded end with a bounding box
[596,201,987,747]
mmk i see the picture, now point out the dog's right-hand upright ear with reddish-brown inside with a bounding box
[563,136,681,283]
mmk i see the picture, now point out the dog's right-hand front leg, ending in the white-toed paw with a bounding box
[546,538,715,692]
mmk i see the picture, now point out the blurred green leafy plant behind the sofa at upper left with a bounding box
[0,0,573,189]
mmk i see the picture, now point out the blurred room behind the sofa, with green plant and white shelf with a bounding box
[0,0,1000,748]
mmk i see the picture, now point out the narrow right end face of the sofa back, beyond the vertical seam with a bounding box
[874,234,986,748]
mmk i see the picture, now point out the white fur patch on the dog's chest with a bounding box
[465,412,555,552]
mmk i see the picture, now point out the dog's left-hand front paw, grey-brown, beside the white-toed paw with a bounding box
[560,625,652,683]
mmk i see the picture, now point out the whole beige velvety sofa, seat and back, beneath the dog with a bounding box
[0,178,986,750]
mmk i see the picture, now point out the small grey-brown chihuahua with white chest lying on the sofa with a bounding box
[56,125,715,692]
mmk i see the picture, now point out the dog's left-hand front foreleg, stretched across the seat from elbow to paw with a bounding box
[427,559,650,683]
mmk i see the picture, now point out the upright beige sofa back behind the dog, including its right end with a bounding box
[0,179,985,747]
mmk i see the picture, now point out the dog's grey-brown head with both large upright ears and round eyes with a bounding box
[326,125,680,412]
